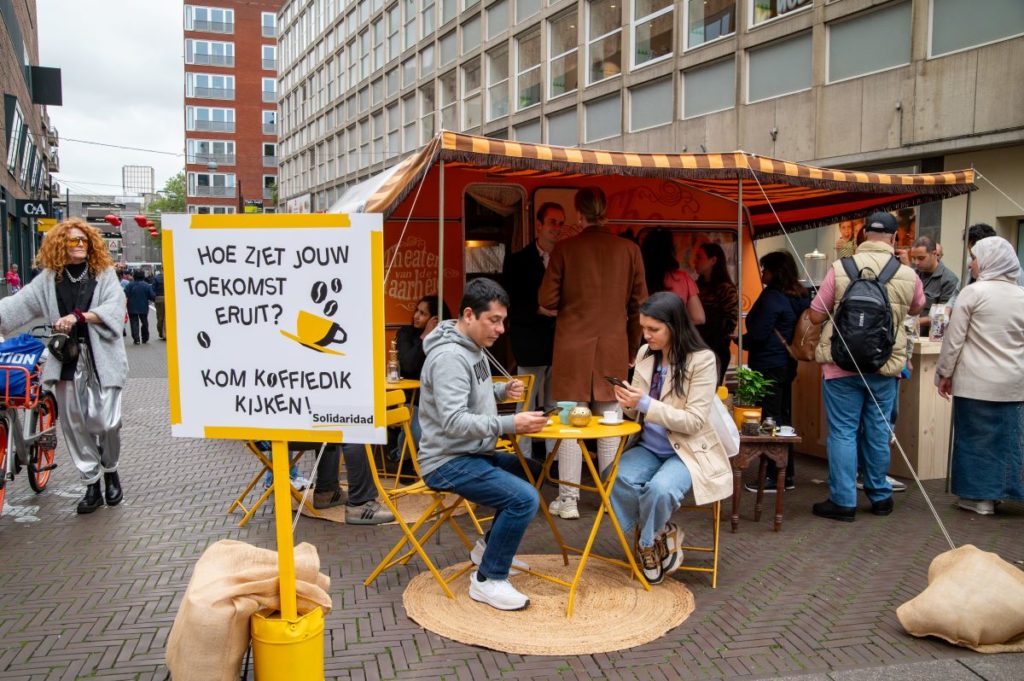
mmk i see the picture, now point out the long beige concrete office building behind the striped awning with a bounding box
[280,0,1024,263]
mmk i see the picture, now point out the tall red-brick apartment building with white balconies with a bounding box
[184,0,281,213]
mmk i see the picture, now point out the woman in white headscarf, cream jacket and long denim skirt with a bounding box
[936,237,1024,515]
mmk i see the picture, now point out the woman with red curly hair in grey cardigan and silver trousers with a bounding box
[0,218,128,513]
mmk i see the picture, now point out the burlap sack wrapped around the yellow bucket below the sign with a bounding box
[167,540,331,681]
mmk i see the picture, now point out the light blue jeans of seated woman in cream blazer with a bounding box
[611,446,693,547]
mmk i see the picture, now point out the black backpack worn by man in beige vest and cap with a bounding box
[831,257,899,374]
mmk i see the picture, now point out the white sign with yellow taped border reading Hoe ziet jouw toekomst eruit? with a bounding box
[163,214,387,443]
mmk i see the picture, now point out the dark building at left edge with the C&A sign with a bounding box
[0,0,60,273]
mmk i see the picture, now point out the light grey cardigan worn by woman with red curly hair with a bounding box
[0,267,128,388]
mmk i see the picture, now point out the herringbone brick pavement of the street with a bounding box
[0,327,1024,681]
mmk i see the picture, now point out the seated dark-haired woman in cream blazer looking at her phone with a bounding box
[611,292,732,584]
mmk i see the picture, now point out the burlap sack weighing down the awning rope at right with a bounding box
[896,544,1024,652]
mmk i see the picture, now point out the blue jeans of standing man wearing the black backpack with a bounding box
[822,374,897,508]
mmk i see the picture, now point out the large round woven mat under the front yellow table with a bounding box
[402,555,693,655]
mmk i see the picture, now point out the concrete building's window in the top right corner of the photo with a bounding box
[929,0,1024,56]
